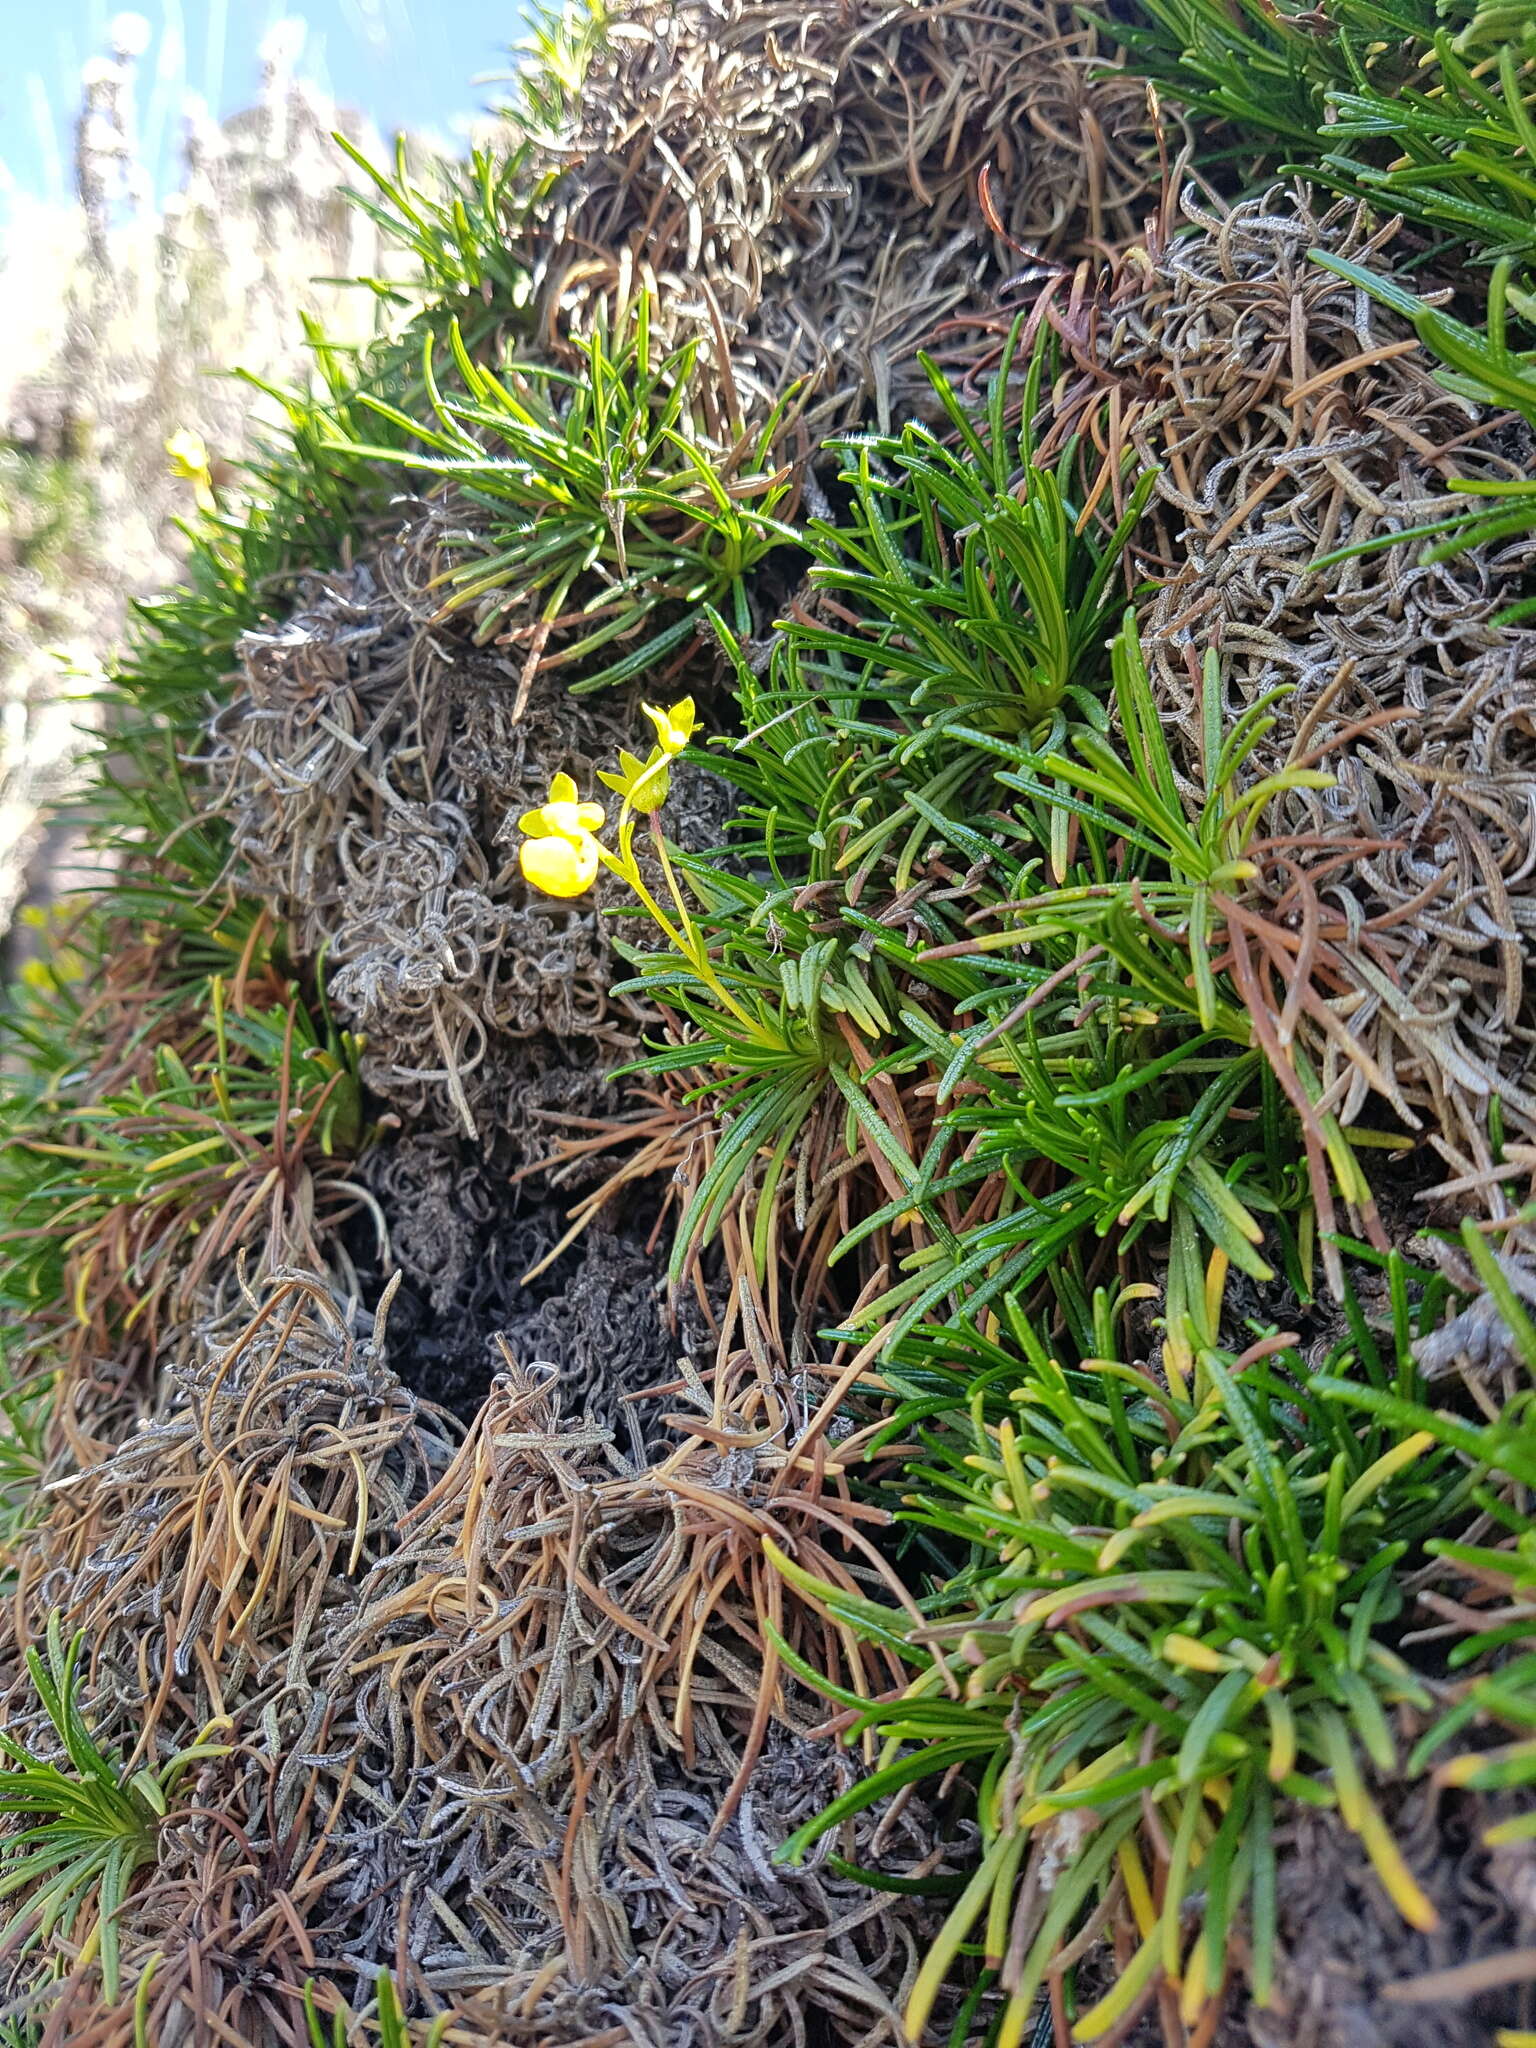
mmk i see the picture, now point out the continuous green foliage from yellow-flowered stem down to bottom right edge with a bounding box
[512,288,1532,2042]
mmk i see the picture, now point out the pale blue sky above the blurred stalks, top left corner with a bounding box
[0,0,524,199]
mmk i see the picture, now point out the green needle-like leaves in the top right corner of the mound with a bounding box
[1124,0,1536,585]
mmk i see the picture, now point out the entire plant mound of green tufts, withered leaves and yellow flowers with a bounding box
[0,0,1536,2048]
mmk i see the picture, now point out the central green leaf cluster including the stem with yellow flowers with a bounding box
[524,333,1370,1310]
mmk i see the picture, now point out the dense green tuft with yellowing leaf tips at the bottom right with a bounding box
[780,1253,1536,2044]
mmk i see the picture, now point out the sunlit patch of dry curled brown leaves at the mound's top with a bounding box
[539,0,1159,436]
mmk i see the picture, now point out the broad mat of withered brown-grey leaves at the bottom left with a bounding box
[0,1274,962,2044]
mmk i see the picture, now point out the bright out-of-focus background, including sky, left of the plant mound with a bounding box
[0,0,524,965]
